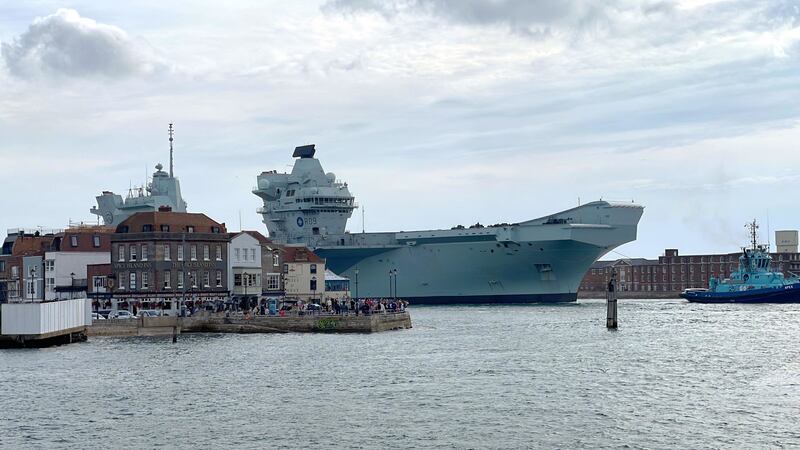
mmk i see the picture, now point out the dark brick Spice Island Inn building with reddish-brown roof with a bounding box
[109,208,230,311]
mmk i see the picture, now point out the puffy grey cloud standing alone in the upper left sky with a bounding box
[0,9,166,78]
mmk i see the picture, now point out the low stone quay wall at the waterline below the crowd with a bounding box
[87,311,411,337]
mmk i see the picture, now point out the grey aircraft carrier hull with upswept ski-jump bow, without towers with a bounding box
[314,202,642,305]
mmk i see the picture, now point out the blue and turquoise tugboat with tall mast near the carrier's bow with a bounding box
[681,220,800,303]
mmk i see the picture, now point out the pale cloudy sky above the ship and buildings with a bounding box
[0,0,800,258]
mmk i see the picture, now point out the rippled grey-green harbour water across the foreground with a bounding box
[0,300,800,448]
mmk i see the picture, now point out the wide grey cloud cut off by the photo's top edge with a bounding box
[323,0,673,36]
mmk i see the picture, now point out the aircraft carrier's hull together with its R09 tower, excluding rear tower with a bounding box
[253,145,644,304]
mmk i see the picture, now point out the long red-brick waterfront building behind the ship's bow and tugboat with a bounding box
[580,249,800,296]
